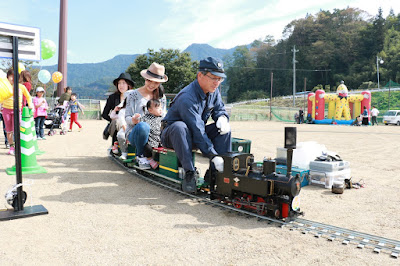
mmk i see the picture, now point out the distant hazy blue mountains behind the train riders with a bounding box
[42,43,236,99]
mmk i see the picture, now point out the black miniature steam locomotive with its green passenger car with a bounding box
[110,127,301,219]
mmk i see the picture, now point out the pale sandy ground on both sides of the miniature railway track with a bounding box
[0,120,400,265]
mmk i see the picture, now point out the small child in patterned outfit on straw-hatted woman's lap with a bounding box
[141,99,163,169]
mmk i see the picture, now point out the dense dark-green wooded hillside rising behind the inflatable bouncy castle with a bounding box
[226,8,400,102]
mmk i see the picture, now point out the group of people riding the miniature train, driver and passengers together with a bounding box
[102,57,231,192]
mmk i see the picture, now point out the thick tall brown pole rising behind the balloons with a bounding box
[57,0,68,96]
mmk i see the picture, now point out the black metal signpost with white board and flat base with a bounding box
[0,22,48,220]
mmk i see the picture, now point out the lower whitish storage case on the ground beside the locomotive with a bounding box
[310,168,351,189]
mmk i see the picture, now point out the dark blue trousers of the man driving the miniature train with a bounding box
[161,121,231,171]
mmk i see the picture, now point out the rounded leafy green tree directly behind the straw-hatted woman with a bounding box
[126,49,199,93]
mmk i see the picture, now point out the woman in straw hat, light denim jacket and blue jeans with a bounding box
[125,62,168,169]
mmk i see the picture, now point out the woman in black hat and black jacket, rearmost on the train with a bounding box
[101,73,135,143]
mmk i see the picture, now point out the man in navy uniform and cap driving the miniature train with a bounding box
[161,57,231,193]
